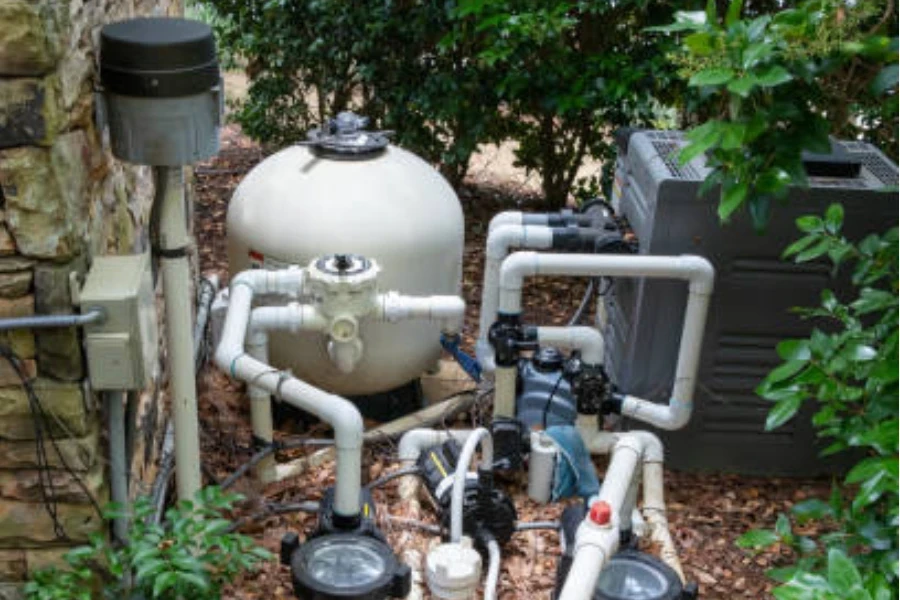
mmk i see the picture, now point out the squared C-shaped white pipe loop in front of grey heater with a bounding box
[500,252,715,430]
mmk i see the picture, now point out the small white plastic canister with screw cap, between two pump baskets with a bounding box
[425,536,481,600]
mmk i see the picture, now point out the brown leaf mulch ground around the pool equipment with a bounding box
[194,127,830,600]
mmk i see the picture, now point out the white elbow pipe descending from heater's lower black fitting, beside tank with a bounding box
[475,223,553,372]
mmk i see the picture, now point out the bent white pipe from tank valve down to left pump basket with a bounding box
[215,269,363,517]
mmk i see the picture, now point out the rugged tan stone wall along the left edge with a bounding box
[0,0,180,600]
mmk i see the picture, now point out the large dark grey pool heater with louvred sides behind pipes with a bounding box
[602,131,897,475]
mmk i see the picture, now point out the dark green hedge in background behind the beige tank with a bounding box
[202,0,678,204]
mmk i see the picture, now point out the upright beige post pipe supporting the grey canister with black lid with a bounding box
[155,166,201,499]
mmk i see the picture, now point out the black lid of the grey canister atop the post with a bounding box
[100,17,219,98]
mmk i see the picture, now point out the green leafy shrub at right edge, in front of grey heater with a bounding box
[739,204,900,599]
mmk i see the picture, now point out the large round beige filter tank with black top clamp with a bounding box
[228,113,464,395]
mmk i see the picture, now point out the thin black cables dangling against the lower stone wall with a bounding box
[0,345,103,539]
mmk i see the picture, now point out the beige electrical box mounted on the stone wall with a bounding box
[80,254,159,390]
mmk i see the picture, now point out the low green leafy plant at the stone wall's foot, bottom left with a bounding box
[25,487,270,600]
